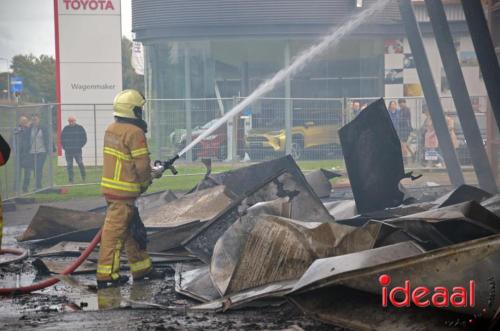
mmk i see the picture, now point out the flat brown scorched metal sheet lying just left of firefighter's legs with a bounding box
[17,206,104,241]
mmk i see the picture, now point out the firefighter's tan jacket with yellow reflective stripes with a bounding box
[101,122,151,199]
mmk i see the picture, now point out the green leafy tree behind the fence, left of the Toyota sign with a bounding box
[11,54,56,102]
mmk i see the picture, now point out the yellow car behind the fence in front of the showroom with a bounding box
[245,121,341,160]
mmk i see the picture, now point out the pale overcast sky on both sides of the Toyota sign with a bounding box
[0,0,132,71]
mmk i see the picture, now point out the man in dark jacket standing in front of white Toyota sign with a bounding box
[61,116,87,184]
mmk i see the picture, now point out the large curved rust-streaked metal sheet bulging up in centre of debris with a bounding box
[210,215,380,295]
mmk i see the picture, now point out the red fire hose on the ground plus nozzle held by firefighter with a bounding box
[0,155,179,295]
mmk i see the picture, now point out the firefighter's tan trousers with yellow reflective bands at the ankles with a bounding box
[97,200,152,280]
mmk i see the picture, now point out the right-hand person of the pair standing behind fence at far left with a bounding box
[23,114,50,192]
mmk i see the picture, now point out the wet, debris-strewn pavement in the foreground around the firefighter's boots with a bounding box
[0,223,341,330]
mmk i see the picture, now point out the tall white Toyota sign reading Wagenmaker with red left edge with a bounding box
[54,0,122,165]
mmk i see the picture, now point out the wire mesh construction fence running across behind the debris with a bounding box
[0,96,488,199]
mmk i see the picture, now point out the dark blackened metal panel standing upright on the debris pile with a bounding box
[339,99,405,213]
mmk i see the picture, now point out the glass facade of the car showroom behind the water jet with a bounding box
[145,37,384,159]
